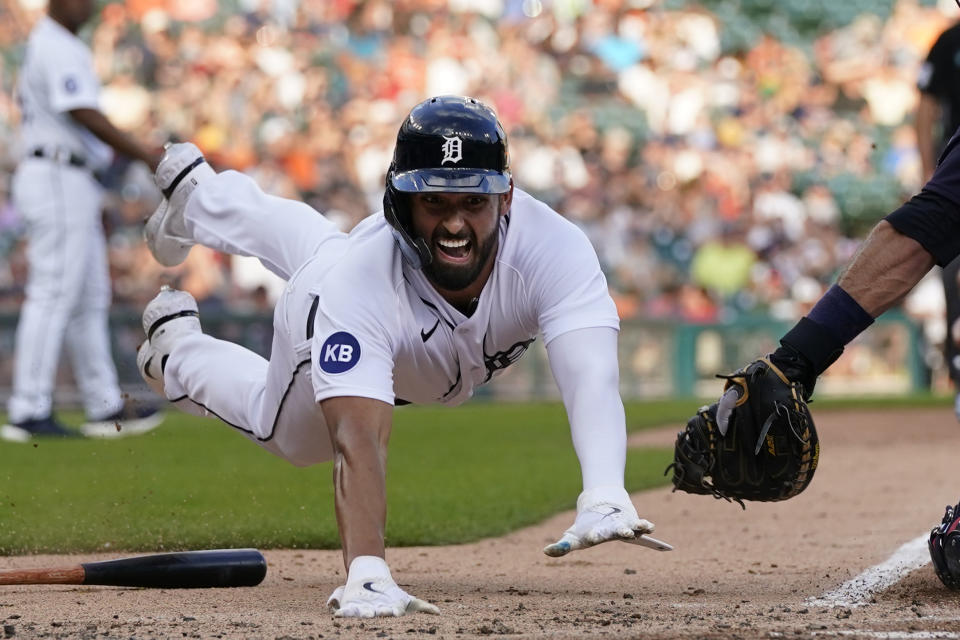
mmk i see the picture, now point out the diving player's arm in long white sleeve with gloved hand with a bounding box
[544,328,653,556]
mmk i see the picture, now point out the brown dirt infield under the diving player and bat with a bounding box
[0,405,960,638]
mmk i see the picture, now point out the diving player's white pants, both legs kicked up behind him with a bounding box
[163,171,347,466]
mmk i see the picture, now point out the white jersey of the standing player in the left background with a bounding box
[17,16,113,169]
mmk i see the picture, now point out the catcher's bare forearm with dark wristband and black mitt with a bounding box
[668,220,935,506]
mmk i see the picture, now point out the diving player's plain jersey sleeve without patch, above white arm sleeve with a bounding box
[528,214,620,344]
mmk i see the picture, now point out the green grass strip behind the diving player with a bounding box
[0,396,950,555]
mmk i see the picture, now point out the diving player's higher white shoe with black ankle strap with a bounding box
[143,142,216,267]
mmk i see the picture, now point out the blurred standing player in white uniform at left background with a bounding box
[0,0,162,442]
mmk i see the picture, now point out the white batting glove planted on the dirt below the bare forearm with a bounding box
[327,556,440,618]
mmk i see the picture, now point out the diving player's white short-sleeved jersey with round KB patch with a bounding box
[311,189,619,405]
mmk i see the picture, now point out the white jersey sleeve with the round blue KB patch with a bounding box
[311,276,394,404]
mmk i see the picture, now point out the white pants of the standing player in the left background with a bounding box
[8,158,123,423]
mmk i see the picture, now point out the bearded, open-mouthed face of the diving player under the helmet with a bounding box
[410,193,510,291]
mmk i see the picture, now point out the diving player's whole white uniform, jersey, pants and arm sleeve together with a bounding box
[164,171,626,478]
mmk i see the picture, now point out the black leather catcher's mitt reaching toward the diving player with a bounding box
[667,358,820,507]
